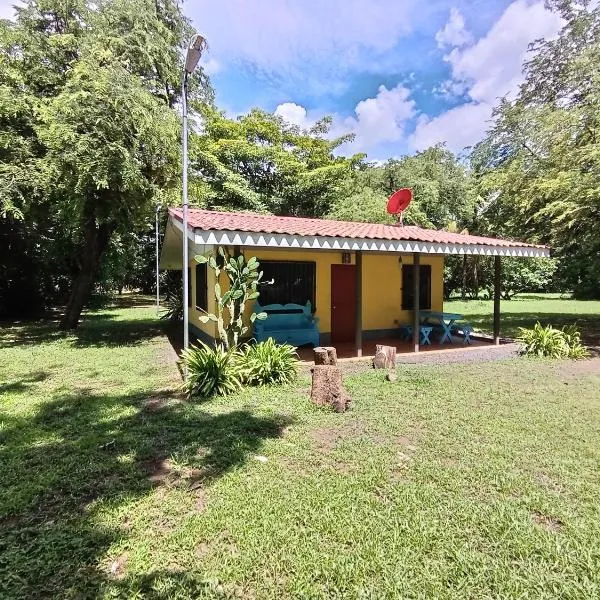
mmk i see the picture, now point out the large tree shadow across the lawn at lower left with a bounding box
[0,391,289,599]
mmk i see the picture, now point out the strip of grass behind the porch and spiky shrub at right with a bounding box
[444,294,600,346]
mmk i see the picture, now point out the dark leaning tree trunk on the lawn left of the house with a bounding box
[60,215,115,329]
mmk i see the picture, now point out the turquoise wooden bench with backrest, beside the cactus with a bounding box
[253,301,319,348]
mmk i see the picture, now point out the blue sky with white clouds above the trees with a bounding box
[0,0,561,160]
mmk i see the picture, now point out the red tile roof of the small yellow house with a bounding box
[169,208,545,248]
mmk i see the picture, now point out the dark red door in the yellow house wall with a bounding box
[331,265,356,343]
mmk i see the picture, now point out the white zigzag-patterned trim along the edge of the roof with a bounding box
[169,217,550,258]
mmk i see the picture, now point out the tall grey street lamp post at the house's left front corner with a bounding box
[181,34,206,358]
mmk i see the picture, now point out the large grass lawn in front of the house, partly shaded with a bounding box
[0,301,600,600]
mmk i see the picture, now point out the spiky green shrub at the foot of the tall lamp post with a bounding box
[181,342,246,398]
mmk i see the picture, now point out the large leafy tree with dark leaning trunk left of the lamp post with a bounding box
[0,0,209,328]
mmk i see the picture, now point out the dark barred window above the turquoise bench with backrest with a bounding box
[258,260,317,310]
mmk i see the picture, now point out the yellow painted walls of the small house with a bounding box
[190,248,444,337]
